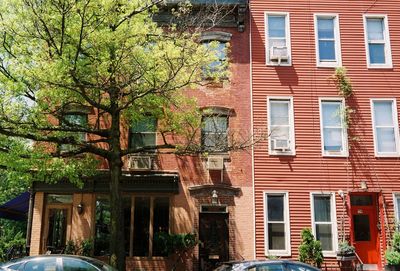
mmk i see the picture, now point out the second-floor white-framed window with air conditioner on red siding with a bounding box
[267,97,296,155]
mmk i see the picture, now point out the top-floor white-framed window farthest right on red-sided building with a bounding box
[364,14,392,68]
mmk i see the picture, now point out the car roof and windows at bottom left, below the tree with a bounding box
[0,254,117,271]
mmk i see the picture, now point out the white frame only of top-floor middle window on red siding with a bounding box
[314,13,342,67]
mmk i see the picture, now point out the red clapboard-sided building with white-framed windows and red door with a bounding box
[250,0,400,270]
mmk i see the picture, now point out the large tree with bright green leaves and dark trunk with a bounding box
[0,0,223,270]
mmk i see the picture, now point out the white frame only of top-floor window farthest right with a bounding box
[363,14,393,69]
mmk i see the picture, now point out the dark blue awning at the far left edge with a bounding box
[0,192,30,220]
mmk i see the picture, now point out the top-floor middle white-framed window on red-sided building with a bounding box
[314,14,342,67]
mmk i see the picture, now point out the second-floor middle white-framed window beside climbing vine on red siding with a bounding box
[319,98,348,156]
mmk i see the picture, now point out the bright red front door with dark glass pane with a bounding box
[350,194,380,269]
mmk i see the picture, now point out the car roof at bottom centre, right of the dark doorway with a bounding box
[214,260,320,271]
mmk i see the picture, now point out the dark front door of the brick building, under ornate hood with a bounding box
[199,213,229,271]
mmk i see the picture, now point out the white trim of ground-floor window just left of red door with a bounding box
[310,192,338,257]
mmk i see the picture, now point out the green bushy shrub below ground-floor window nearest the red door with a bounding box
[299,228,324,268]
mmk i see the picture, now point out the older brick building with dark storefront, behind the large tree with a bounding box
[30,0,254,270]
